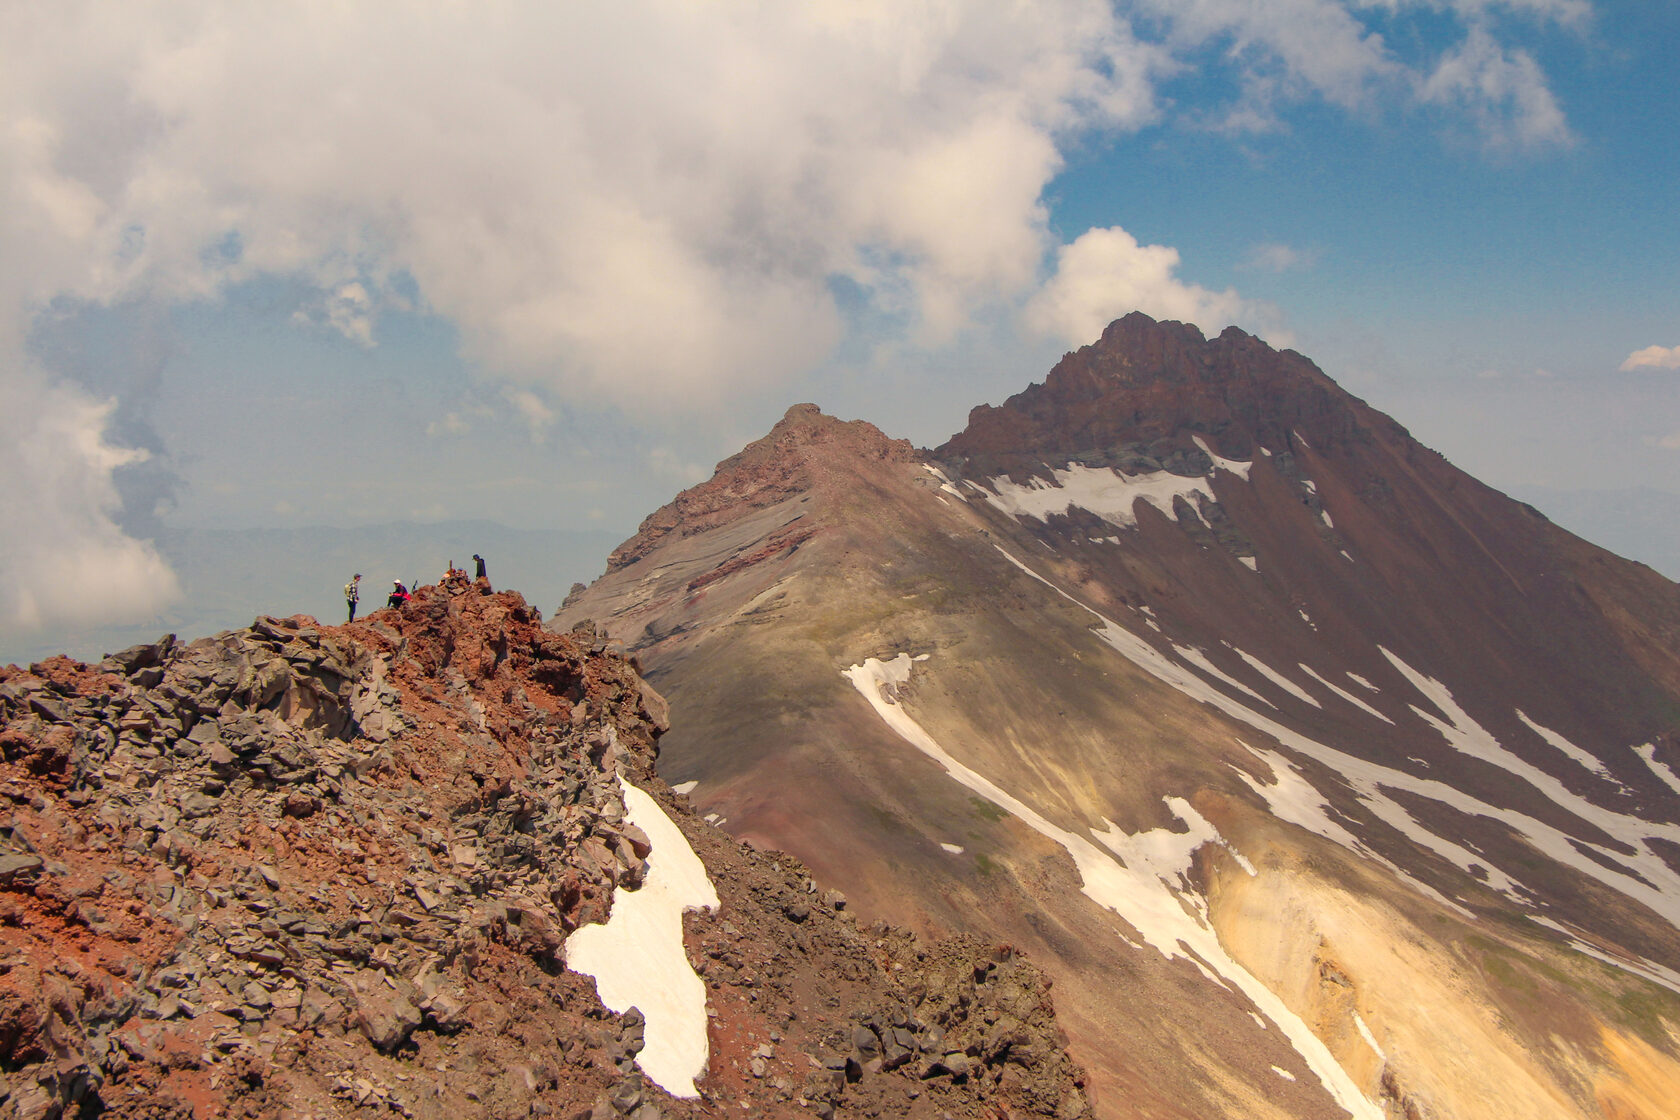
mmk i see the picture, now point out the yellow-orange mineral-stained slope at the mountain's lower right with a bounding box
[1210,848,1659,1120]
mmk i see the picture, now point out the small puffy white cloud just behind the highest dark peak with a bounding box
[1026,227,1270,344]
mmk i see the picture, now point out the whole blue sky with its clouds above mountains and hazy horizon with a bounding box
[0,0,1680,655]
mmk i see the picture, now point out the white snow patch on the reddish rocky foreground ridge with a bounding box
[566,777,717,1098]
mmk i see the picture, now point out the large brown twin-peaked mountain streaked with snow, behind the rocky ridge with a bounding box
[559,316,1680,1118]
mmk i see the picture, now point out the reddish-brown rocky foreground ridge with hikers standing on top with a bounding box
[0,578,1089,1120]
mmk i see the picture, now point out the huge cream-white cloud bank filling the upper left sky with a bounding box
[0,0,1166,408]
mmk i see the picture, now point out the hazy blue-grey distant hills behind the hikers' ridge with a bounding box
[0,521,622,663]
